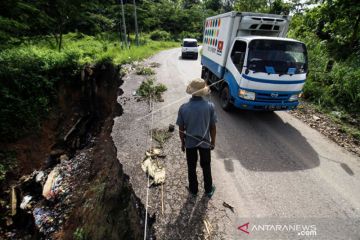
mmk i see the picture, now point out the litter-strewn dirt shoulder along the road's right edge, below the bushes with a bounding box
[290,101,360,156]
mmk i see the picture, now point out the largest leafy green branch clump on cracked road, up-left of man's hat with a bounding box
[137,78,167,101]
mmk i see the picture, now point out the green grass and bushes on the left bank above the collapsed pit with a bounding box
[0,33,177,141]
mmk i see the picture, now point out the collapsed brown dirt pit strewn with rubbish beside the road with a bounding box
[0,64,144,239]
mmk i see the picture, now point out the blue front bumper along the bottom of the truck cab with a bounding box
[232,97,299,111]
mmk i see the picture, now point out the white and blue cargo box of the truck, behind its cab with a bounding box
[201,11,290,77]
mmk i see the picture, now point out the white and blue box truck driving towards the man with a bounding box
[201,12,308,111]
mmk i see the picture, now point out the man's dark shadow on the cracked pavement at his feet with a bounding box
[165,194,209,240]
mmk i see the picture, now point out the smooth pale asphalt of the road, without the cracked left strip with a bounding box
[151,48,360,239]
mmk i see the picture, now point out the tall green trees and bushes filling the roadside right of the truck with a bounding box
[290,1,360,117]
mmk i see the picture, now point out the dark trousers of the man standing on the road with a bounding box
[186,147,212,194]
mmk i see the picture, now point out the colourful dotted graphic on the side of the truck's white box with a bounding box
[204,18,224,56]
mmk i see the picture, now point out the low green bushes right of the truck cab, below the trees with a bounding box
[290,27,360,117]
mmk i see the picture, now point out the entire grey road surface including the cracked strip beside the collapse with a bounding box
[112,48,360,239]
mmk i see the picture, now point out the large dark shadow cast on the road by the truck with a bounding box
[211,93,320,172]
